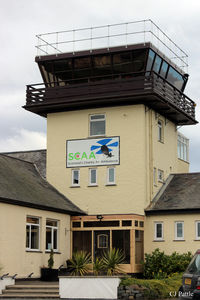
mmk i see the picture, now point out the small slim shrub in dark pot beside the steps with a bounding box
[41,249,58,281]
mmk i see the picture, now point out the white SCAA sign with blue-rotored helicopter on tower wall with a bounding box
[66,137,120,168]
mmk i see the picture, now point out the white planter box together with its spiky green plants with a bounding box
[59,249,124,299]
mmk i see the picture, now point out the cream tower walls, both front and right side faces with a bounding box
[47,105,185,215]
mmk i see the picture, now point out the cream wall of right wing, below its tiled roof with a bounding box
[144,214,200,254]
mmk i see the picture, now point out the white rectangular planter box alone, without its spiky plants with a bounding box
[59,276,120,299]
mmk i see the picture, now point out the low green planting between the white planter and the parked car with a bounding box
[120,273,182,298]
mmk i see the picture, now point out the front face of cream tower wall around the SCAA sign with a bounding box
[47,105,146,214]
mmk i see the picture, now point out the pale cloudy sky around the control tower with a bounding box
[0,0,200,171]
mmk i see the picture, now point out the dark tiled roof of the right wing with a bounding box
[145,173,200,215]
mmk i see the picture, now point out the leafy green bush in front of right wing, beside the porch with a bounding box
[144,248,192,279]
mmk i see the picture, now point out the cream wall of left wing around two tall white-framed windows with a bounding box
[0,203,70,278]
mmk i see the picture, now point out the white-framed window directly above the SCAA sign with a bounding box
[90,114,106,136]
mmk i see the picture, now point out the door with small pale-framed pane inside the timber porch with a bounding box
[94,230,110,259]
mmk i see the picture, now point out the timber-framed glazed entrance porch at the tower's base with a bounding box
[71,214,144,273]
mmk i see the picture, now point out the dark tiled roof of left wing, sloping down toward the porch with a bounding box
[0,154,85,215]
